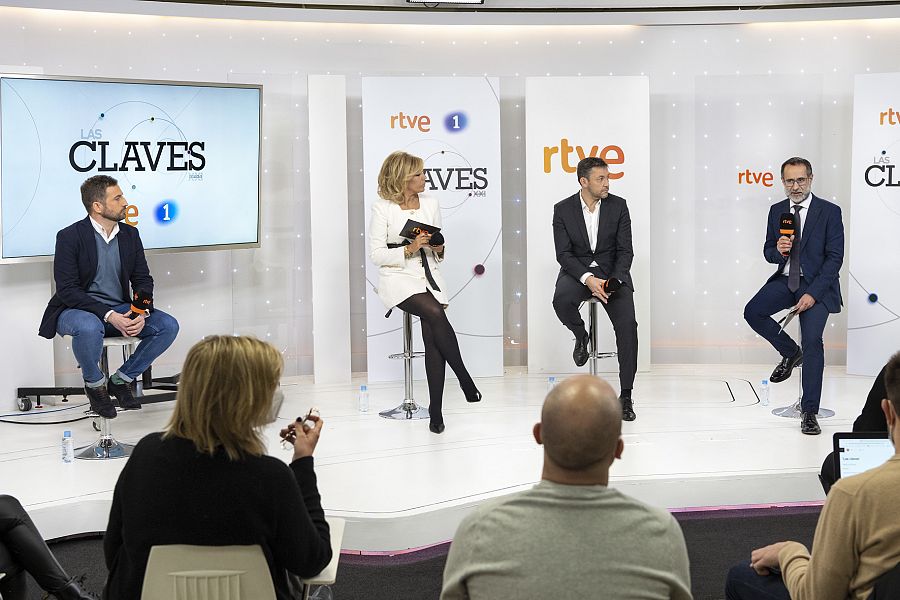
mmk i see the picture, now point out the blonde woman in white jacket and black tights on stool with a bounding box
[369,151,481,433]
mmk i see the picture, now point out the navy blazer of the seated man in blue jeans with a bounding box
[38,217,153,339]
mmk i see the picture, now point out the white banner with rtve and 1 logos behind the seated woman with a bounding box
[363,77,503,382]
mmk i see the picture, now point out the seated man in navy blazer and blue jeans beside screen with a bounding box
[38,175,178,419]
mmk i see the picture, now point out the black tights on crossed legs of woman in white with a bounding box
[397,292,477,424]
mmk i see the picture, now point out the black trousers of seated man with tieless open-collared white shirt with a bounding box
[553,273,637,390]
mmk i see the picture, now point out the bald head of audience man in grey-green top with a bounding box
[541,375,622,471]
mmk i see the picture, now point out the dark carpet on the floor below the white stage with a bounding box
[29,507,820,600]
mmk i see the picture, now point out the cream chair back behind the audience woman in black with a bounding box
[141,544,275,600]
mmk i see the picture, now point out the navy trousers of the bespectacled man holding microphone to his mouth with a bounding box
[744,276,828,413]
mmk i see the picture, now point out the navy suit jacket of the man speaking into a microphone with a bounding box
[763,194,844,313]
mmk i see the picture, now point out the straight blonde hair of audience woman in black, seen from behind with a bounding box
[163,335,284,460]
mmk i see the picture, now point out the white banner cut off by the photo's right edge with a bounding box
[843,73,900,375]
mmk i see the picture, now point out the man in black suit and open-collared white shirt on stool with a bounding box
[553,156,638,421]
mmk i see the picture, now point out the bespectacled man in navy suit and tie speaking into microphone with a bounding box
[744,157,844,435]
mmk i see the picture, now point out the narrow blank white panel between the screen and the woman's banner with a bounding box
[308,75,350,383]
